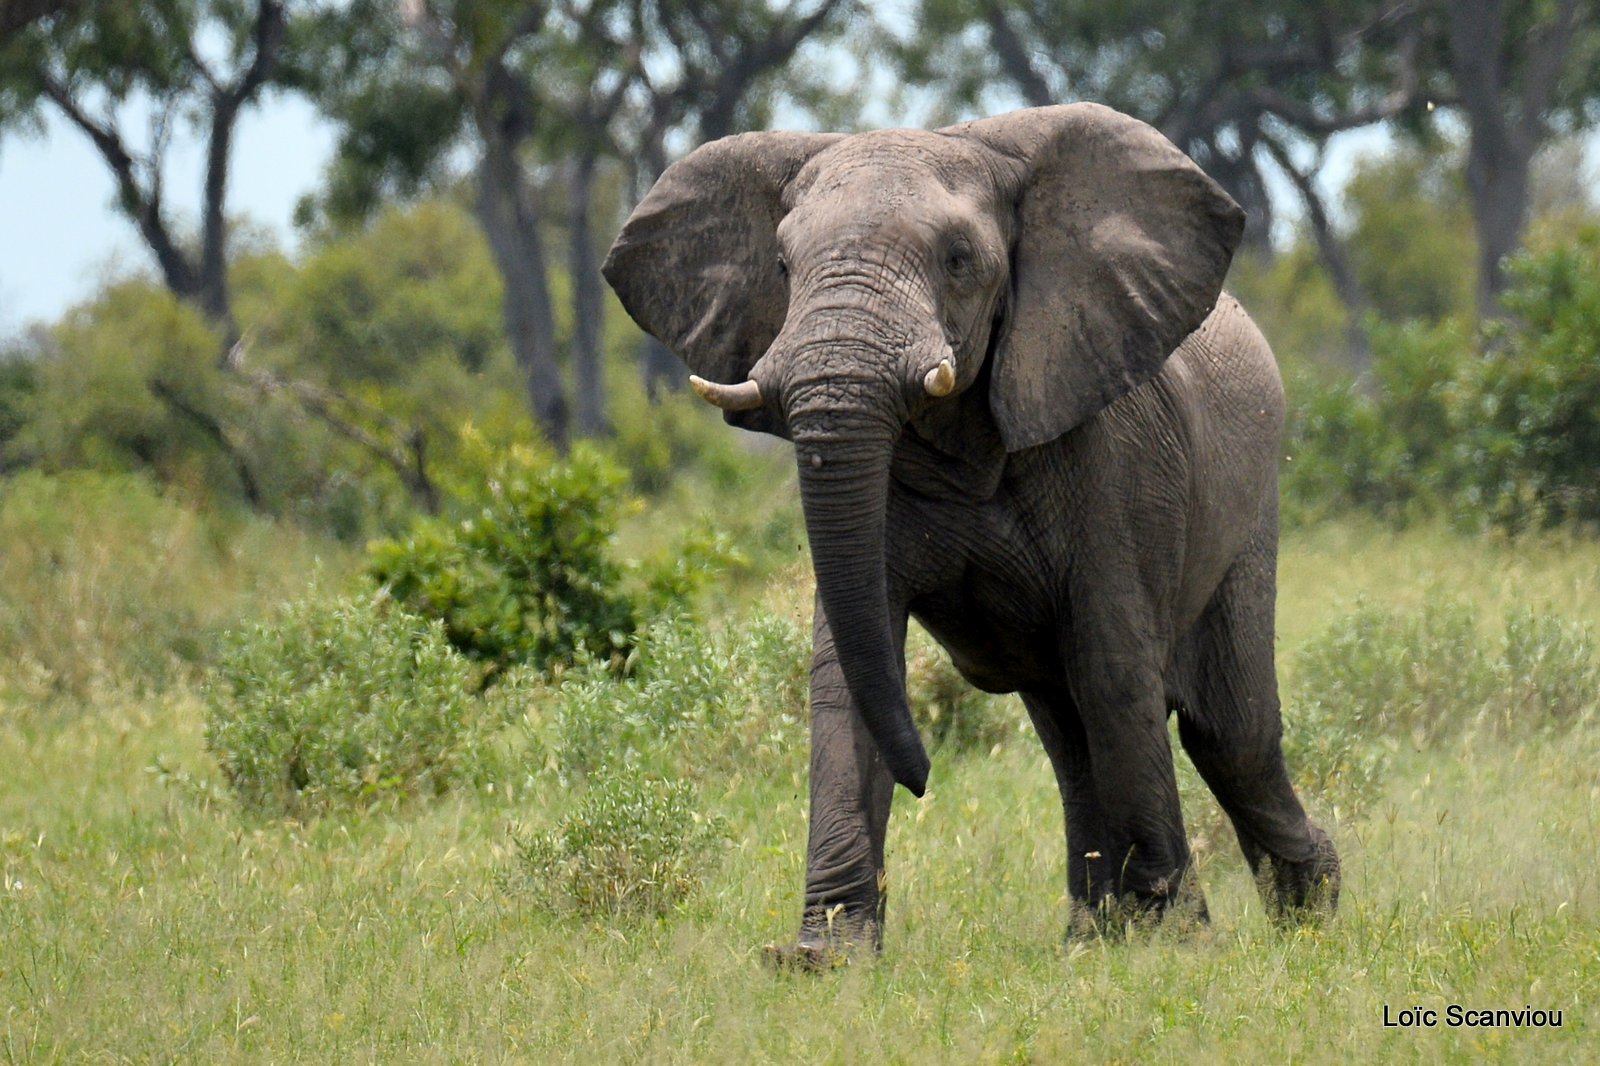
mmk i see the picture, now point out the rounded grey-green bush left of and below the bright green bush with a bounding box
[206,595,488,816]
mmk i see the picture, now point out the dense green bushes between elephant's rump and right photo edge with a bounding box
[1282,227,1600,533]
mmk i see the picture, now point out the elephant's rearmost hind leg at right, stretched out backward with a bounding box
[1178,554,1339,917]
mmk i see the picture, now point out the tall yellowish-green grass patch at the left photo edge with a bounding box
[0,471,350,703]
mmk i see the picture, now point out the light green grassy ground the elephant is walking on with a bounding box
[0,512,1600,1063]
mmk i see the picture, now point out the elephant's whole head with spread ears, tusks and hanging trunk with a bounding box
[605,104,1243,795]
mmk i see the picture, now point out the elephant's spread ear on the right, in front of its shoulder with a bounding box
[944,104,1245,451]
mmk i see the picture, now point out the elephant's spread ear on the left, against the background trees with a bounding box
[602,133,845,431]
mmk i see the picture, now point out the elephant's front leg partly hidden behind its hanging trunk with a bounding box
[768,602,906,968]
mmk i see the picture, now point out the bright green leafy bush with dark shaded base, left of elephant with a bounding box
[371,445,640,669]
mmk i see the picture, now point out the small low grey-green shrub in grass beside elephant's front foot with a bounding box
[517,775,728,920]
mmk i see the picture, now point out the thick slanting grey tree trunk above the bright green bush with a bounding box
[478,122,571,453]
